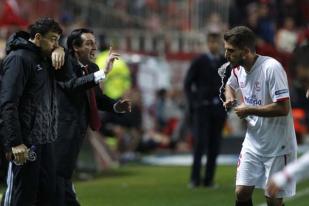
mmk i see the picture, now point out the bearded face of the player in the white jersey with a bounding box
[224,41,244,66]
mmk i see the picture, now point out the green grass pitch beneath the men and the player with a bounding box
[75,165,309,206]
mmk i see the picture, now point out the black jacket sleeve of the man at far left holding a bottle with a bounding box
[0,56,31,151]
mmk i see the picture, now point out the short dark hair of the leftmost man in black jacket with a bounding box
[28,17,62,39]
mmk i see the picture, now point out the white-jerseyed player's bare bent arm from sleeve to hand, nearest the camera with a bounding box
[235,99,290,119]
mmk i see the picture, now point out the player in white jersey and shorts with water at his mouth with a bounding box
[224,26,297,206]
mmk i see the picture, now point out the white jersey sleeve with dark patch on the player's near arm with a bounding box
[268,63,290,102]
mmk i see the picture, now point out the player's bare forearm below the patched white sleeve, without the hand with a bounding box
[244,102,290,117]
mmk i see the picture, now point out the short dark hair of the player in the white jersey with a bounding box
[223,26,256,51]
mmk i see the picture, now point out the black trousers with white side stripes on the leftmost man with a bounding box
[1,144,56,206]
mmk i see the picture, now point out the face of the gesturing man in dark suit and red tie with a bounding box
[74,33,97,64]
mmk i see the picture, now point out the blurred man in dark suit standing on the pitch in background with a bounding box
[184,33,226,187]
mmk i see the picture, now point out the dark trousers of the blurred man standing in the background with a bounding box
[191,106,226,185]
